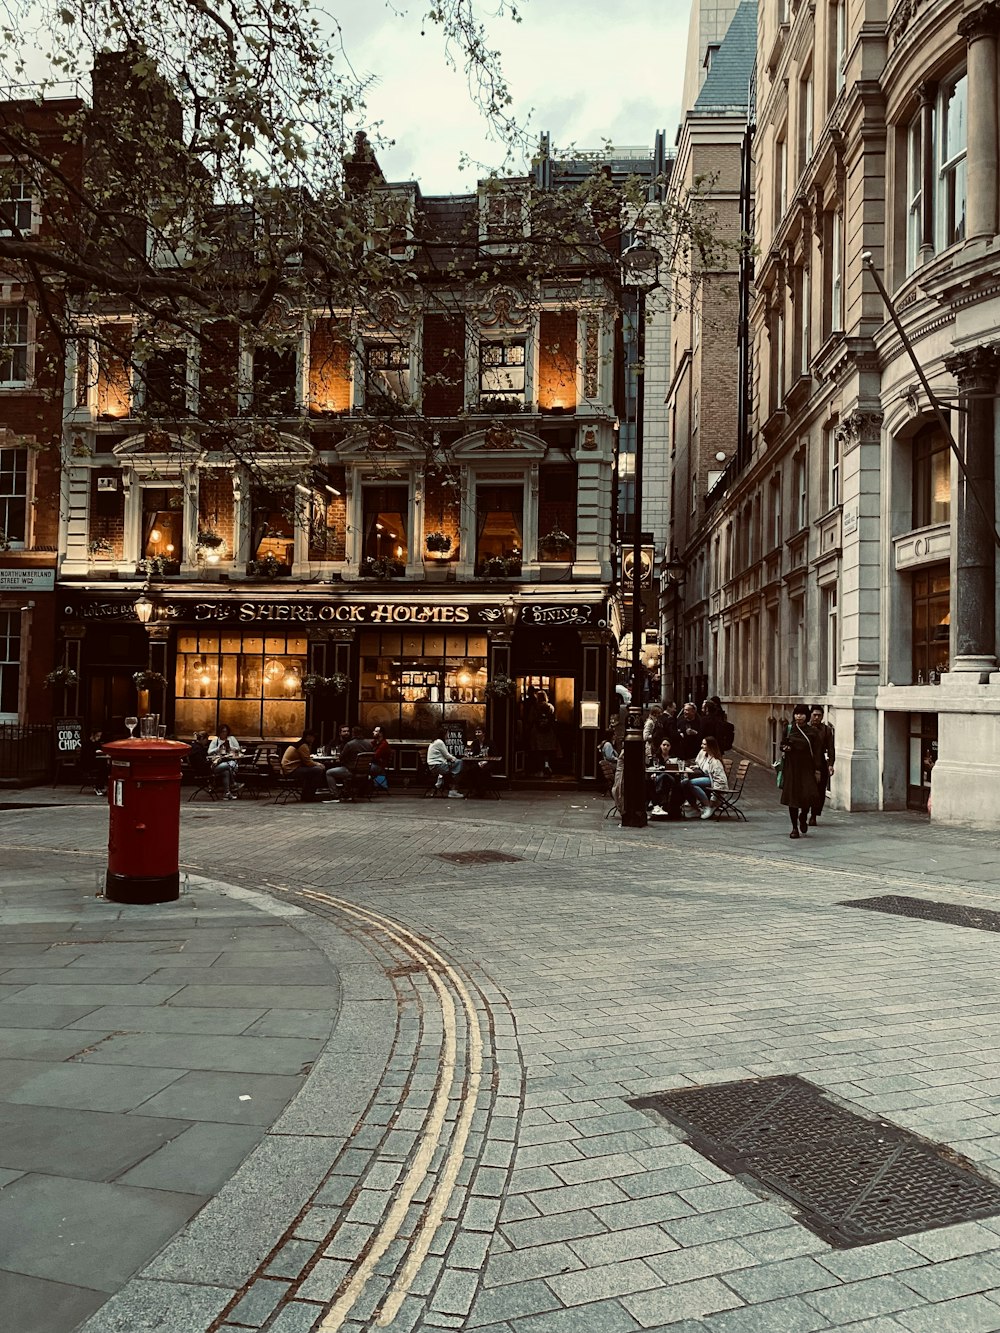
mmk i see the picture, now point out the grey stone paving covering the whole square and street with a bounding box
[0,781,1000,1333]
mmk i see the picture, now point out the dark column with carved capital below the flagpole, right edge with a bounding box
[944,347,1000,685]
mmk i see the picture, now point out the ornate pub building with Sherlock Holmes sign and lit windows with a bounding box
[45,131,619,781]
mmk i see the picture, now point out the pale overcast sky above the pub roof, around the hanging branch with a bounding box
[335,0,688,195]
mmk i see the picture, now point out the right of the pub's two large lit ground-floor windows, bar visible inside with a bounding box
[359,631,487,742]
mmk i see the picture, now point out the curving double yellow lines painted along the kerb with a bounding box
[301,889,483,1333]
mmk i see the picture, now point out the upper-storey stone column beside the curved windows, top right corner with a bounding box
[959,3,1000,240]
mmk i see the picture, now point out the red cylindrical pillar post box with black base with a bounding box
[101,740,191,902]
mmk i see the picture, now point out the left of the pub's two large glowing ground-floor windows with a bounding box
[175,633,308,741]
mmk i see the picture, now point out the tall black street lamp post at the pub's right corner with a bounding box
[621,235,660,829]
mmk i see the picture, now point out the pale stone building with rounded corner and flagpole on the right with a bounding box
[675,0,1000,828]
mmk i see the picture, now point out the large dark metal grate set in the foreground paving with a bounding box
[631,1074,1000,1246]
